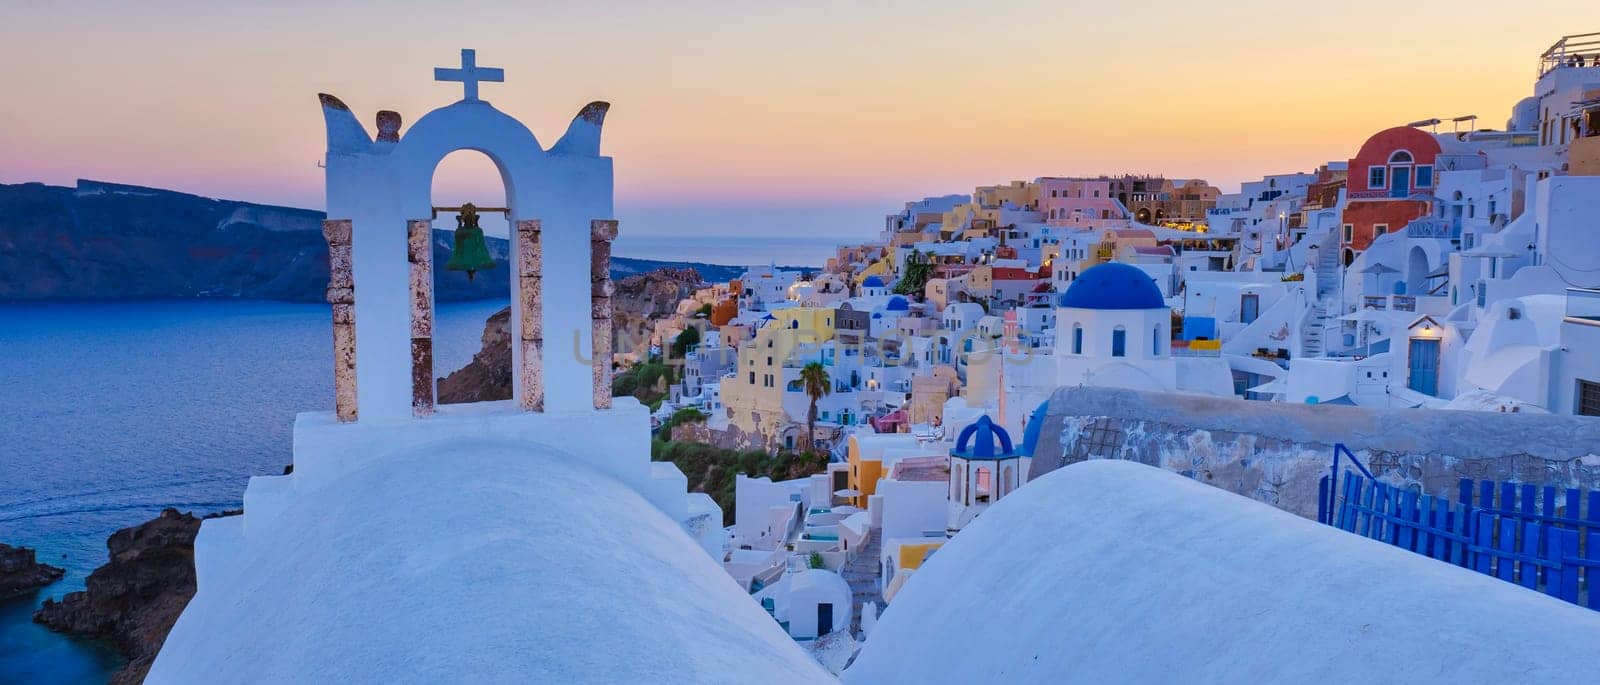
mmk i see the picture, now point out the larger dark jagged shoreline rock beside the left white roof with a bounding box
[34,509,200,683]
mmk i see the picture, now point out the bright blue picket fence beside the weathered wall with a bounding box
[1318,464,1600,610]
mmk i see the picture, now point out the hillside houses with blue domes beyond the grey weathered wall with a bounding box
[614,35,1600,659]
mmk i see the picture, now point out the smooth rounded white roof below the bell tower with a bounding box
[149,445,829,683]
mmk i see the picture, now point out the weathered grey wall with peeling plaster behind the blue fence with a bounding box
[1029,387,1600,517]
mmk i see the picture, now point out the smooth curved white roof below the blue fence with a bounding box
[845,461,1600,683]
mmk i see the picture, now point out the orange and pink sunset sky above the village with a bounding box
[0,0,1600,235]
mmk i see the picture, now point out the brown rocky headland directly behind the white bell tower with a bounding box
[438,267,702,403]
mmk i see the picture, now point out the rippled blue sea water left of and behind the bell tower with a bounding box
[0,299,506,685]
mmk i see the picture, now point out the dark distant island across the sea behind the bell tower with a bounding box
[0,181,744,302]
